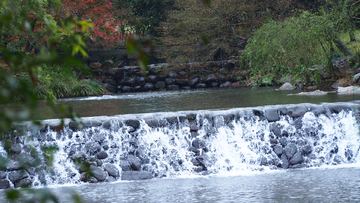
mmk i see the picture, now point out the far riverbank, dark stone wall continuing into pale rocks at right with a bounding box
[90,57,359,93]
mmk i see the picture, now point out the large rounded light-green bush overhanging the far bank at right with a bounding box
[243,12,333,85]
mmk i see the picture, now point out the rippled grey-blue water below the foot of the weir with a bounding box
[33,167,360,202]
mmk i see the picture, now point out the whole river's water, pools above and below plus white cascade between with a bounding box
[0,88,360,202]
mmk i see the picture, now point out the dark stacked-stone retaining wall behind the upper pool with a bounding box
[90,60,245,93]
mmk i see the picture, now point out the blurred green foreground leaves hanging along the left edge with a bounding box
[0,0,92,202]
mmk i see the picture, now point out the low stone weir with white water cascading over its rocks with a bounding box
[0,102,360,188]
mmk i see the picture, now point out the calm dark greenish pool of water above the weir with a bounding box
[38,87,360,119]
